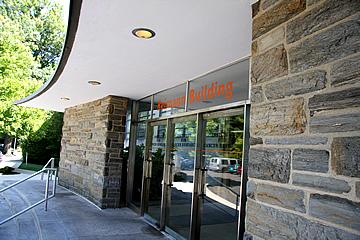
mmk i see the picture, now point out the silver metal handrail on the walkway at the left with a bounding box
[0,158,57,225]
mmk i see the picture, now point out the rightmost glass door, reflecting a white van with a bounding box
[200,108,244,240]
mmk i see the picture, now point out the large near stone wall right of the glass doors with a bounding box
[246,0,360,240]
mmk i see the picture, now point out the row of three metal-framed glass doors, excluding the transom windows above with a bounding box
[140,107,248,239]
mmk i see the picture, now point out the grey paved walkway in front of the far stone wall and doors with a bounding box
[0,178,168,240]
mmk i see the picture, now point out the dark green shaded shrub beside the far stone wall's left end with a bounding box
[21,113,63,165]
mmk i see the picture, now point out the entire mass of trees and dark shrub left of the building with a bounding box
[0,0,65,158]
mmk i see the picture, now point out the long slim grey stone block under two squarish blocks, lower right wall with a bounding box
[292,173,351,193]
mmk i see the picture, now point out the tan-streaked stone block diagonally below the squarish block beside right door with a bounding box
[253,183,305,213]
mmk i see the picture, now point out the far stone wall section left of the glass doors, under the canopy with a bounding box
[59,96,128,208]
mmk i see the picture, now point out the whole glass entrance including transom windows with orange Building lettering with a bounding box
[127,58,250,240]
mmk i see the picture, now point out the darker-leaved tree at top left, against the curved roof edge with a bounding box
[0,0,65,82]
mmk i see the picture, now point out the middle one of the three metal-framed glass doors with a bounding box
[166,116,196,239]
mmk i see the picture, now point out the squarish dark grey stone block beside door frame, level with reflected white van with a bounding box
[249,148,291,183]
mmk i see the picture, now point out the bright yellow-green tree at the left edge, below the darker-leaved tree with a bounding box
[0,15,49,152]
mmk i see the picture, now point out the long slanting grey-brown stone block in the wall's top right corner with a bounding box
[286,0,360,43]
